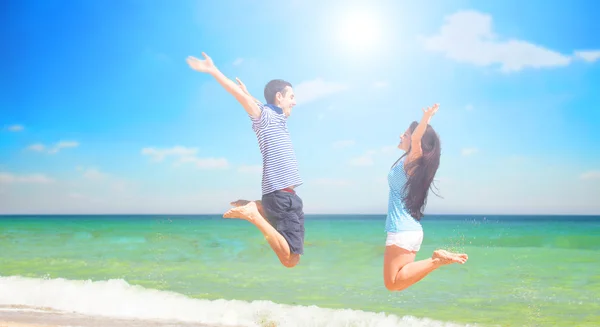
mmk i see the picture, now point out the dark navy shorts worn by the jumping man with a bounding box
[262,190,304,254]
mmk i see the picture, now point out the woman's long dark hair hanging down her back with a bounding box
[394,121,442,220]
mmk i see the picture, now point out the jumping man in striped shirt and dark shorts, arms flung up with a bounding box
[187,53,304,268]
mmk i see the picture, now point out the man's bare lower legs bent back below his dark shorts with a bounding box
[223,200,300,268]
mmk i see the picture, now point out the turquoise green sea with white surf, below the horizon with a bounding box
[0,215,600,326]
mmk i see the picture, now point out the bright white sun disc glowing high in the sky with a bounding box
[338,10,382,50]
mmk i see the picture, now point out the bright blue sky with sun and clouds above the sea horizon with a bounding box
[0,0,600,214]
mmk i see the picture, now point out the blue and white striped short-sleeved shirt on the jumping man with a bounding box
[250,103,302,195]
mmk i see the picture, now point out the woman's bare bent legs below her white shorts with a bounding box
[383,245,468,291]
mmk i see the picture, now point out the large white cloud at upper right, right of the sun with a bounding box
[423,11,598,73]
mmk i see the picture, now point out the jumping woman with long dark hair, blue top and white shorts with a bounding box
[383,104,468,291]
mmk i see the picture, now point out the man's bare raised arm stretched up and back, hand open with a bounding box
[187,52,260,118]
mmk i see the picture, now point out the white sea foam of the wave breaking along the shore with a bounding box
[0,276,478,327]
